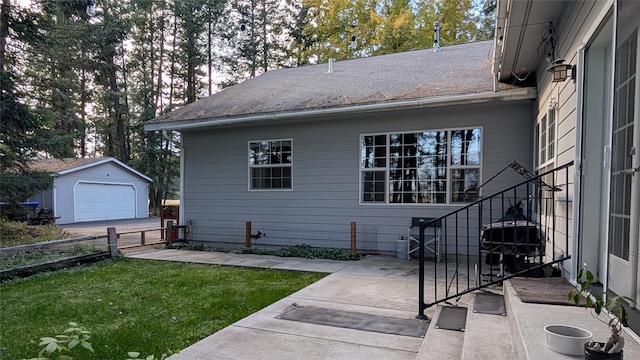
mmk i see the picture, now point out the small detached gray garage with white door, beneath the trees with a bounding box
[30,158,152,224]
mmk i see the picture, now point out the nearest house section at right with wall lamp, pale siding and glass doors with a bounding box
[496,0,640,334]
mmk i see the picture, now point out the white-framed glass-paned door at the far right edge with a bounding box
[608,1,640,299]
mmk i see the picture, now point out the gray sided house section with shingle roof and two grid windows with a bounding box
[145,41,537,254]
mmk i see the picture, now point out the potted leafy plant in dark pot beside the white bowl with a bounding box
[568,264,635,360]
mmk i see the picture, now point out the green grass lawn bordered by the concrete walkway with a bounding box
[0,259,326,360]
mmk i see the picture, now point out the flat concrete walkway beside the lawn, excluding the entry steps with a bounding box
[127,250,433,360]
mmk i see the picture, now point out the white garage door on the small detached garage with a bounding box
[73,183,136,222]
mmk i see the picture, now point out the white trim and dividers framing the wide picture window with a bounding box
[358,125,484,206]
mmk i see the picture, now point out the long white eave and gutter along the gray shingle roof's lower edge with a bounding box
[144,87,537,131]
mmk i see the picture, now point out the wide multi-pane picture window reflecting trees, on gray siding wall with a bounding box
[360,128,482,204]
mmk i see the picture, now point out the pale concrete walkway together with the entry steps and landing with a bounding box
[126,248,640,360]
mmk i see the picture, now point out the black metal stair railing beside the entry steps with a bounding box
[417,161,573,319]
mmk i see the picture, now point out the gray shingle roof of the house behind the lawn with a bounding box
[147,41,508,124]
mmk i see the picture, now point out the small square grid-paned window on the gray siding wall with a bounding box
[249,139,293,190]
